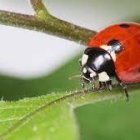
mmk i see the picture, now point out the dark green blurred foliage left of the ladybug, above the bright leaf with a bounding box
[0,55,80,100]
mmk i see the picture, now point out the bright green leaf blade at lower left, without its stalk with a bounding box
[0,93,77,140]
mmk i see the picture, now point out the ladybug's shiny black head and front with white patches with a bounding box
[81,48,115,83]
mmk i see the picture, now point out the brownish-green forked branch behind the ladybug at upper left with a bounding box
[0,0,96,45]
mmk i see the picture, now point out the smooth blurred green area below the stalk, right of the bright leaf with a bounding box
[75,89,140,140]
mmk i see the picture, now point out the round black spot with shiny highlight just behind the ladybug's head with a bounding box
[107,39,123,53]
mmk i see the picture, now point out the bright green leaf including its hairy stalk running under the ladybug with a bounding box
[0,86,138,140]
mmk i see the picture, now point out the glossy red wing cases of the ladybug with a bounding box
[87,23,140,84]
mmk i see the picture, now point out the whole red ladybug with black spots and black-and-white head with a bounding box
[80,23,140,96]
